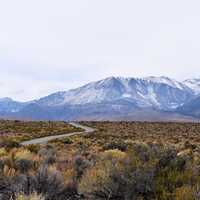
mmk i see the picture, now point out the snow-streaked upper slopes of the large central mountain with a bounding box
[37,77,193,110]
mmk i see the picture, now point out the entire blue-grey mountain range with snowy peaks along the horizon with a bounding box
[0,76,200,121]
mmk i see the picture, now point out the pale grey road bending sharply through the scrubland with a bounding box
[21,122,95,146]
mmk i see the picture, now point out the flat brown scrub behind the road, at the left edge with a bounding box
[0,120,82,142]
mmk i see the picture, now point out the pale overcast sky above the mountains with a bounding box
[0,0,200,101]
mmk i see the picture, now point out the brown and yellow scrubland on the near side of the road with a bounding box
[0,122,200,200]
